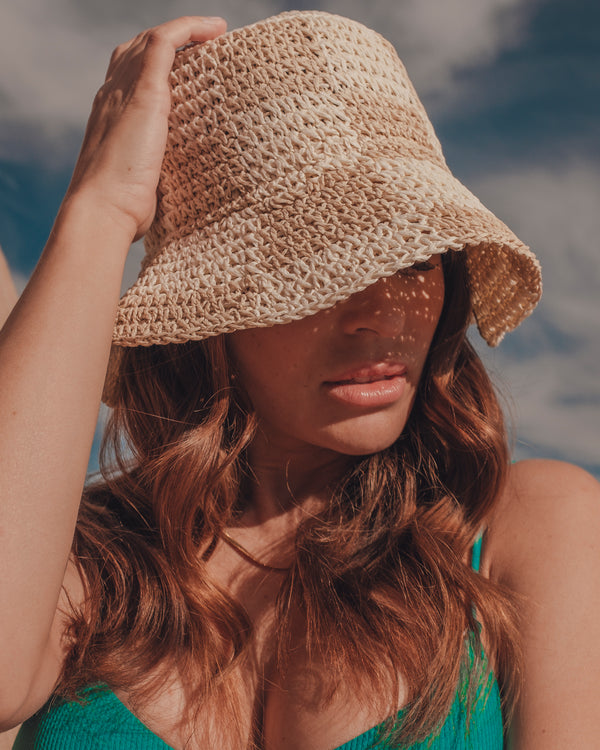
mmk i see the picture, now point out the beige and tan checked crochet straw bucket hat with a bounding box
[105,11,541,401]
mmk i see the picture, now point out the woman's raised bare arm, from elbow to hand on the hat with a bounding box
[0,17,225,729]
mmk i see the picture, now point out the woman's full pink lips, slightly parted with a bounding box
[323,362,406,407]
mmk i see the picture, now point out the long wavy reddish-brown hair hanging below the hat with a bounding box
[57,252,520,743]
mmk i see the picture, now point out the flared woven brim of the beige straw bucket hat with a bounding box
[105,157,541,400]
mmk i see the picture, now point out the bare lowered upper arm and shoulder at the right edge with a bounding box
[487,461,600,750]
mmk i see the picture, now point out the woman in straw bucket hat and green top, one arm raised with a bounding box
[0,13,600,750]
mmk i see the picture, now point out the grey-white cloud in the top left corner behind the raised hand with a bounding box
[0,0,278,157]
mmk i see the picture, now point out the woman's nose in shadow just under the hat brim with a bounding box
[338,276,406,338]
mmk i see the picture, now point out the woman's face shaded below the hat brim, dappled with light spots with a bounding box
[228,256,444,455]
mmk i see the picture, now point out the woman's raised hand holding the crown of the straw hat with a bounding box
[67,16,226,240]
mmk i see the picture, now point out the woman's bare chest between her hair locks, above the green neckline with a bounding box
[113,558,403,750]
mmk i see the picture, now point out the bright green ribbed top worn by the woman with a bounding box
[13,537,503,750]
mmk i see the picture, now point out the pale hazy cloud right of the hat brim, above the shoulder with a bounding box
[471,161,600,467]
